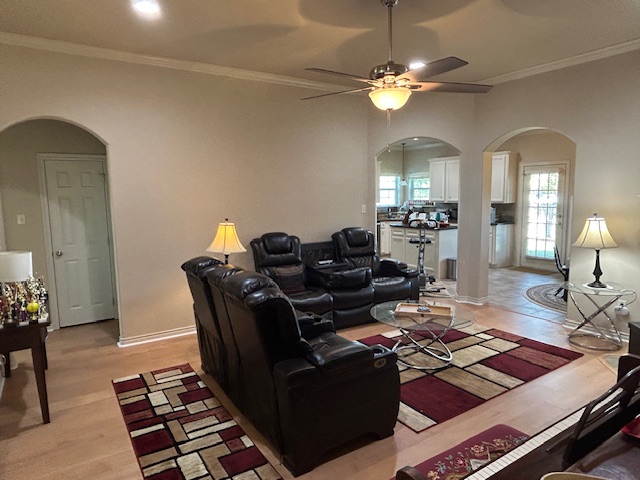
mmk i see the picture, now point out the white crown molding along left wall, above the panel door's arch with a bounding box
[0,32,344,91]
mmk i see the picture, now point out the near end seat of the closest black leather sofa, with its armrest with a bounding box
[214,270,400,476]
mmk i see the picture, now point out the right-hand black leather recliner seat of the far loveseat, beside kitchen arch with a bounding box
[331,227,420,304]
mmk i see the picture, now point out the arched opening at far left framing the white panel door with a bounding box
[0,119,117,339]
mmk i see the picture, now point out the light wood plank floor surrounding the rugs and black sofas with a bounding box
[0,306,626,480]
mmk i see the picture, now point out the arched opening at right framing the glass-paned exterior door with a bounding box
[485,128,576,313]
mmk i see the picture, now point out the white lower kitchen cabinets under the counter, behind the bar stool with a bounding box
[391,227,458,278]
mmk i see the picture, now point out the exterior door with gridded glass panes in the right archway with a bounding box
[520,164,566,270]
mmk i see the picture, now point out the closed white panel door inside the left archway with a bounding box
[44,159,115,327]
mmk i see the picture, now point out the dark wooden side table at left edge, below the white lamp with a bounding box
[0,317,51,423]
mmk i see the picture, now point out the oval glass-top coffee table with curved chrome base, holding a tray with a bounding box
[371,300,474,370]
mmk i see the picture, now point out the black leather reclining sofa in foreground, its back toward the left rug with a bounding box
[182,257,400,476]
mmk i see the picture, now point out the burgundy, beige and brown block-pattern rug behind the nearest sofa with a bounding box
[113,364,281,480]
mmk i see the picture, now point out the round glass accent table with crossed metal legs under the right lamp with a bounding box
[566,283,636,351]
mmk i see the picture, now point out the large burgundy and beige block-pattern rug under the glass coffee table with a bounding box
[360,324,582,432]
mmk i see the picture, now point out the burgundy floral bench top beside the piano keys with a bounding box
[394,425,529,480]
